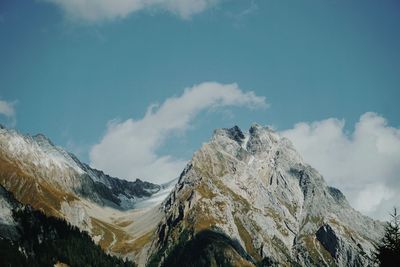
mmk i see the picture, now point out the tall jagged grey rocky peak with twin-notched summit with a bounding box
[149,125,383,266]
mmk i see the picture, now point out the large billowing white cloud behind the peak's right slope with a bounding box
[282,112,400,219]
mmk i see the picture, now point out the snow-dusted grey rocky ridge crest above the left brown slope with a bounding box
[1,128,161,211]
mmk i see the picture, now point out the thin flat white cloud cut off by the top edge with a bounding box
[43,0,221,22]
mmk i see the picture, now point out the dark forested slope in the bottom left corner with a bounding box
[0,207,136,267]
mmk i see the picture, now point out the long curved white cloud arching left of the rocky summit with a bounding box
[89,82,266,183]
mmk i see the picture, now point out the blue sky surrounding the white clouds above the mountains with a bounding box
[0,0,400,218]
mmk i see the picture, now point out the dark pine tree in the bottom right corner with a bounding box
[375,208,400,267]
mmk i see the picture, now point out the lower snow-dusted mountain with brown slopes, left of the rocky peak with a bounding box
[0,127,166,260]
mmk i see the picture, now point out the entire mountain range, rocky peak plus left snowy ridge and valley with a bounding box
[0,124,384,266]
